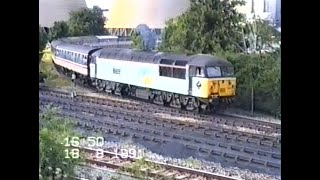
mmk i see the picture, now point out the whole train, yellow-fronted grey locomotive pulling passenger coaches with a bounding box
[51,37,236,112]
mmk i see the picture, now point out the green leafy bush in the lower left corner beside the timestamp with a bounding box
[39,109,82,177]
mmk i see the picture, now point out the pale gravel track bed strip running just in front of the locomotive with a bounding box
[41,86,281,133]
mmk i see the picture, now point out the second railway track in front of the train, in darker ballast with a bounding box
[39,90,281,148]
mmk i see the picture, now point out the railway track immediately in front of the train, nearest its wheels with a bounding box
[40,87,281,135]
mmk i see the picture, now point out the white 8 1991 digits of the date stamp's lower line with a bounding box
[96,148,144,159]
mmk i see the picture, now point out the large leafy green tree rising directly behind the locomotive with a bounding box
[162,0,244,54]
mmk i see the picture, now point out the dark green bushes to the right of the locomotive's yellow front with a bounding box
[227,53,281,116]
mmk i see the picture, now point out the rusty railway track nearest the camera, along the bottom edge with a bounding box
[73,147,244,180]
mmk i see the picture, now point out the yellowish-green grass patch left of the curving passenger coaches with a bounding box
[39,50,71,87]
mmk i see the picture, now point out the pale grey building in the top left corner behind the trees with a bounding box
[39,0,87,28]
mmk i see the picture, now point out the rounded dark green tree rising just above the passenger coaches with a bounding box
[68,6,106,36]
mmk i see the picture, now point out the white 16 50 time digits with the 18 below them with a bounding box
[64,136,104,159]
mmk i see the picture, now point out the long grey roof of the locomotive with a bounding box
[94,48,232,67]
